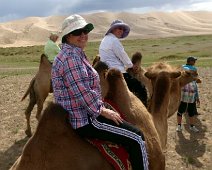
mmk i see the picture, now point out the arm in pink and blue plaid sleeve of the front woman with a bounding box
[64,51,103,118]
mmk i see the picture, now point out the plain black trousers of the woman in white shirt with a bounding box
[123,73,147,107]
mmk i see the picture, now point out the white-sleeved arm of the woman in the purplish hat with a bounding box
[113,39,133,68]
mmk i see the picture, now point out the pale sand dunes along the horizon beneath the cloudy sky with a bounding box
[0,11,212,47]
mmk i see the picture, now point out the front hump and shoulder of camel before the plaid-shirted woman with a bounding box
[94,62,165,170]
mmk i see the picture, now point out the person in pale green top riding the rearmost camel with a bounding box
[44,33,60,63]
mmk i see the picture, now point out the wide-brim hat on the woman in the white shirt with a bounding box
[105,20,130,38]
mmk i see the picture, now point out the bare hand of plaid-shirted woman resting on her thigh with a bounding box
[100,108,123,125]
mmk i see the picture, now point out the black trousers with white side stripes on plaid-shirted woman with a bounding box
[76,115,148,170]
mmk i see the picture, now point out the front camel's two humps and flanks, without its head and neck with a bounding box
[11,62,165,170]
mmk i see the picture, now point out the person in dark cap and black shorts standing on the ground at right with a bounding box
[176,56,201,132]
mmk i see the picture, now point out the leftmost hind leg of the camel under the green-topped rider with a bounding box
[25,94,36,137]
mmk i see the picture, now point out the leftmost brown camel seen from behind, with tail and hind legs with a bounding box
[21,54,52,137]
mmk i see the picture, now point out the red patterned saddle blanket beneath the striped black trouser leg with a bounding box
[88,139,131,170]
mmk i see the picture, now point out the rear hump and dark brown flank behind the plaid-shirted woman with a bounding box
[10,103,114,170]
